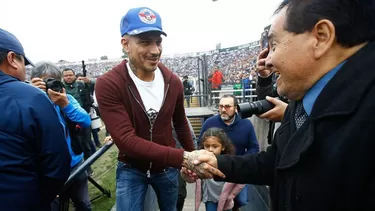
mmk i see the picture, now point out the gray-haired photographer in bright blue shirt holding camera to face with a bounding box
[31,62,91,211]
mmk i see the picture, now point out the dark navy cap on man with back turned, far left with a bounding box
[0,29,34,66]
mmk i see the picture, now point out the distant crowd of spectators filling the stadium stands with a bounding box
[27,42,259,84]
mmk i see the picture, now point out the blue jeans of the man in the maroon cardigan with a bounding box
[116,162,178,211]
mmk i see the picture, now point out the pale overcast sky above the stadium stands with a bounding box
[0,0,281,62]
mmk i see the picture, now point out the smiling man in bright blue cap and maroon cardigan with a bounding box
[95,7,225,211]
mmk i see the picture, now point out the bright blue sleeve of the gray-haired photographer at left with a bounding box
[63,94,91,128]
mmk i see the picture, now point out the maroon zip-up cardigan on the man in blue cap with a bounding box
[95,60,194,172]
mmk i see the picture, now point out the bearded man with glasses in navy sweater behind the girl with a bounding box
[199,95,259,210]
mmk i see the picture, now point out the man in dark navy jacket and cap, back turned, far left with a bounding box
[0,29,71,211]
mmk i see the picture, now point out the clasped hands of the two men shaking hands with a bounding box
[181,149,225,182]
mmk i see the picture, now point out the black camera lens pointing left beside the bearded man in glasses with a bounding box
[237,100,275,119]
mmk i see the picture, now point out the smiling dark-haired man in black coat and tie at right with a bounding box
[186,0,375,211]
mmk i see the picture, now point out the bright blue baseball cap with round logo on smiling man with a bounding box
[120,7,167,36]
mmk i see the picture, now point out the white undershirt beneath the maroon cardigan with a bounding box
[126,63,164,119]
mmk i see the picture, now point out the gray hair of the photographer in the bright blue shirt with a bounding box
[31,62,62,80]
